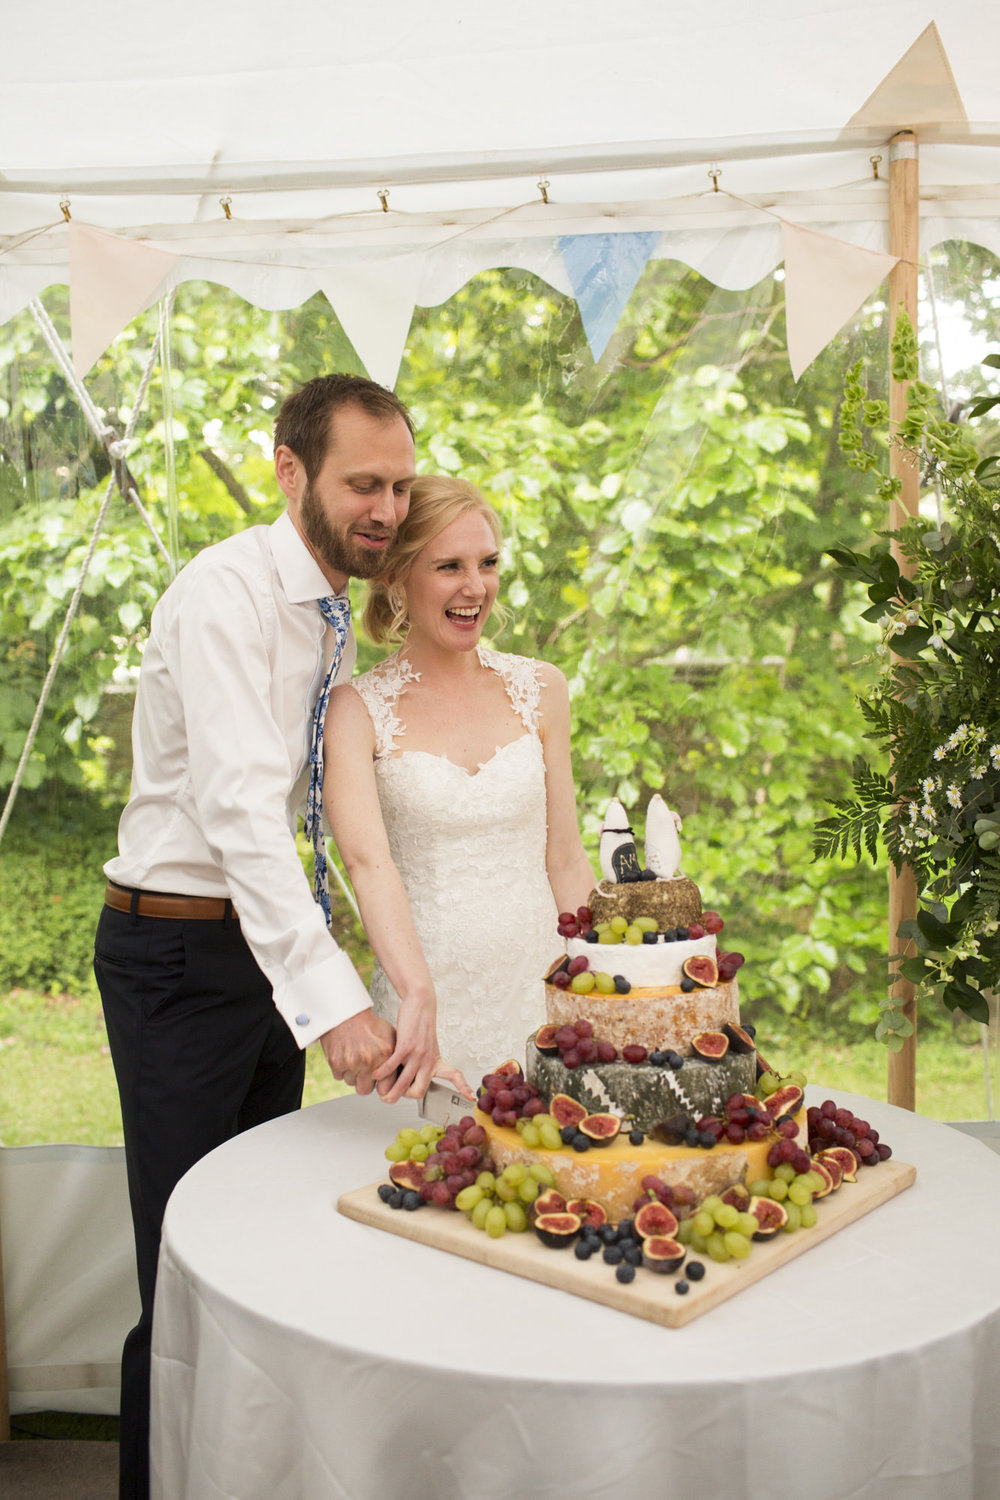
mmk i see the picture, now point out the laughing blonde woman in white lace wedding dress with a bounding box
[324,476,594,1098]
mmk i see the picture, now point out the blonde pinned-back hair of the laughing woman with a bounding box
[361,474,507,645]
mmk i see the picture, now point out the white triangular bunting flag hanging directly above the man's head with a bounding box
[319,255,423,390]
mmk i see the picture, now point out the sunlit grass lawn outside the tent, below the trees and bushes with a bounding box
[0,990,1000,1146]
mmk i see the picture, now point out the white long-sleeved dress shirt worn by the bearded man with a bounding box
[105,513,370,1047]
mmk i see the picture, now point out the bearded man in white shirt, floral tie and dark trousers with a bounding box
[94,375,435,1500]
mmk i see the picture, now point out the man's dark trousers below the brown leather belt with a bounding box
[94,906,306,1500]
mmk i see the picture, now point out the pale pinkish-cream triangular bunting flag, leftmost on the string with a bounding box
[69,221,178,380]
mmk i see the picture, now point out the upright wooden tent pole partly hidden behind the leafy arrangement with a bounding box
[888,131,921,1110]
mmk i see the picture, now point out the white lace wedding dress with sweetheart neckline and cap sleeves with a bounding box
[352,647,558,1088]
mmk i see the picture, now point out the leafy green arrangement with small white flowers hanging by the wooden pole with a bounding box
[814,317,1000,1049]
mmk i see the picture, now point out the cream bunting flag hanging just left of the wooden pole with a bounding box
[781,219,898,380]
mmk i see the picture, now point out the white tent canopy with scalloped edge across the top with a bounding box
[0,0,1000,380]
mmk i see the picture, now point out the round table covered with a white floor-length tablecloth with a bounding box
[153,1089,1000,1500]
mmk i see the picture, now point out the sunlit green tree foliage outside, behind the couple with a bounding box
[0,252,995,1025]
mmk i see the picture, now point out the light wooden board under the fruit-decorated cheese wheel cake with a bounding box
[337,1158,916,1328]
